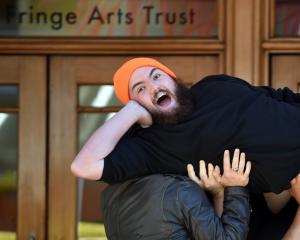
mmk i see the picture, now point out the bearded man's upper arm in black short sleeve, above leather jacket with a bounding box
[100,133,186,183]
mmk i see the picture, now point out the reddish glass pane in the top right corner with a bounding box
[275,0,300,37]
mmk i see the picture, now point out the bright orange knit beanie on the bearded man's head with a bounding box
[114,58,176,104]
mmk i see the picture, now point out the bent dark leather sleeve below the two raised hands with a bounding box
[178,185,250,240]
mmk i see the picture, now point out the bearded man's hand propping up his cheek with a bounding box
[126,100,152,127]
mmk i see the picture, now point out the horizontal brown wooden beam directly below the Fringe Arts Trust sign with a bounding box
[0,38,224,55]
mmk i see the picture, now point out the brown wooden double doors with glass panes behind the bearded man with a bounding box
[0,54,223,239]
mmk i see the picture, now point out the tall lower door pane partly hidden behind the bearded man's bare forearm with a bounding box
[77,113,115,239]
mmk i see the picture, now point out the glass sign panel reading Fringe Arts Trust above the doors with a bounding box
[0,0,218,38]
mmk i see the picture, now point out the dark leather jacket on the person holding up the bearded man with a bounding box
[102,174,250,240]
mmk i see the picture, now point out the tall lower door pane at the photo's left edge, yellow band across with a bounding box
[0,113,18,236]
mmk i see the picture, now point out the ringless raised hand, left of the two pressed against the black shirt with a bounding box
[187,160,224,196]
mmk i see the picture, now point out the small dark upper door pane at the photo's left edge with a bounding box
[0,85,19,108]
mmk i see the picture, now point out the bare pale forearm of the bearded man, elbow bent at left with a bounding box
[71,105,137,180]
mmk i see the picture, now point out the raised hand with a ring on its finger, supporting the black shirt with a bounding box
[216,149,251,187]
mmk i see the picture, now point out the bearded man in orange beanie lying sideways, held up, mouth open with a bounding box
[71,58,300,207]
